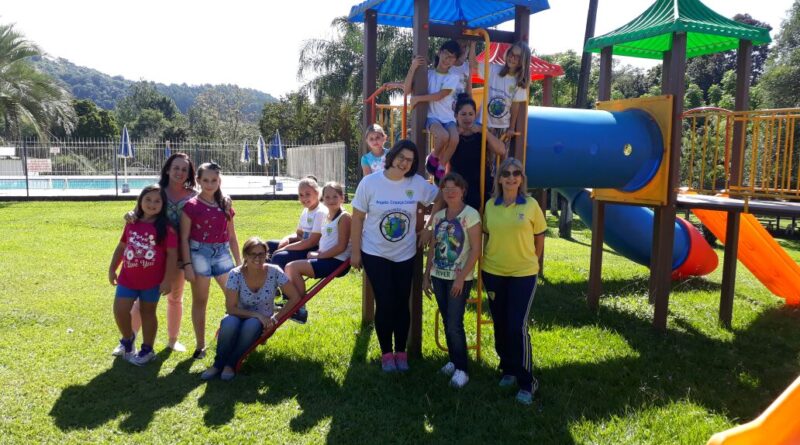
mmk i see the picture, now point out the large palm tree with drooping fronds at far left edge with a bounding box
[0,25,75,139]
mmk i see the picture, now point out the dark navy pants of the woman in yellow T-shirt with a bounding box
[482,272,536,391]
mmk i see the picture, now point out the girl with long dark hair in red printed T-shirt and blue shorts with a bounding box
[108,184,178,366]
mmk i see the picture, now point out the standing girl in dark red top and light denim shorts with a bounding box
[180,162,242,359]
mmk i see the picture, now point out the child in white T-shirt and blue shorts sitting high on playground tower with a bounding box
[404,40,461,183]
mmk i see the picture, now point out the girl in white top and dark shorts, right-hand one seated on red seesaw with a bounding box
[286,182,350,297]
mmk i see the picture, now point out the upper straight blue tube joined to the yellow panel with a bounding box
[526,107,664,191]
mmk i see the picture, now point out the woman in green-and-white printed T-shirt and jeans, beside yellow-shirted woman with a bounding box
[422,172,481,388]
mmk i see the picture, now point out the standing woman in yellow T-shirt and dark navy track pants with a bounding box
[481,158,547,405]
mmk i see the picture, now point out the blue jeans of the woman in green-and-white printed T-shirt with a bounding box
[431,277,472,372]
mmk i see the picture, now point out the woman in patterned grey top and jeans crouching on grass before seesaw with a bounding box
[200,237,300,380]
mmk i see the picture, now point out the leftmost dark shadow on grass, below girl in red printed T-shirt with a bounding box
[50,349,200,432]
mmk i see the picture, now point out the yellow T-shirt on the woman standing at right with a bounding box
[482,196,547,277]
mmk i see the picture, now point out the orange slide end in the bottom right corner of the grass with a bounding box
[707,377,800,445]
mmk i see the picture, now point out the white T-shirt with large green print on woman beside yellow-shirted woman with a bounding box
[431,206,481,280]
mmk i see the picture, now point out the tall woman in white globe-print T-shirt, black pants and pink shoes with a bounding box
[350,139,438,372]
